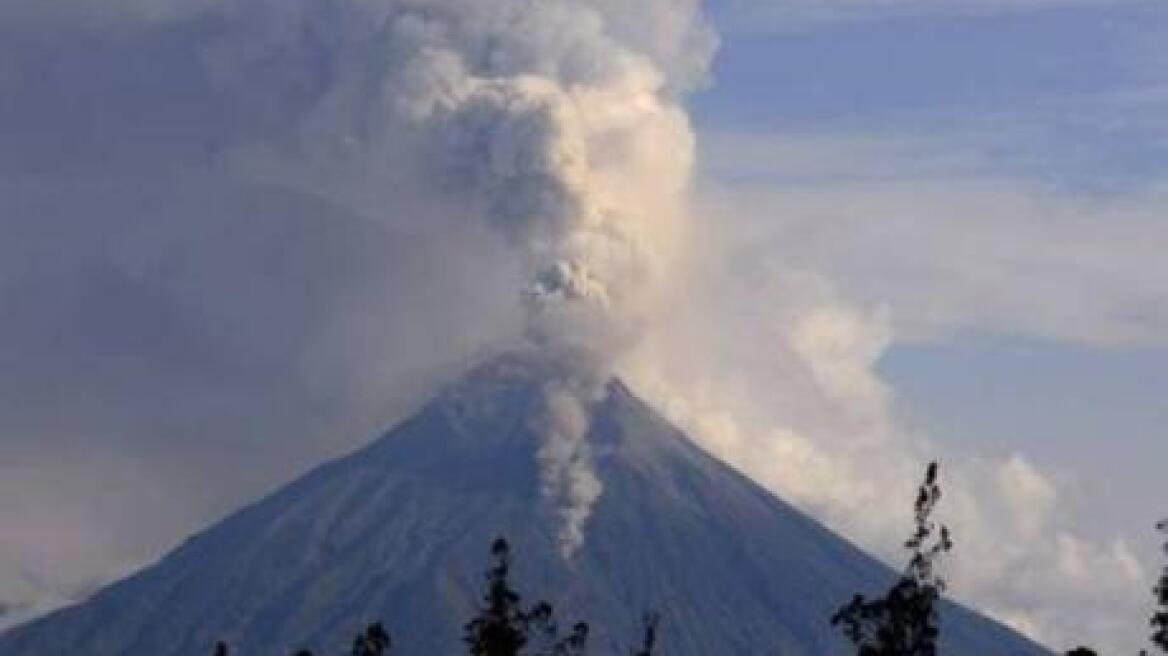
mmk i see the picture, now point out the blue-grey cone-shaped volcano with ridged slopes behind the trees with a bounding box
[0,355,1049,656]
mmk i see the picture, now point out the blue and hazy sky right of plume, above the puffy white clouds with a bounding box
[693,0,1168,649]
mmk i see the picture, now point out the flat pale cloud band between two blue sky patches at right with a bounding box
[691,138,1168,346]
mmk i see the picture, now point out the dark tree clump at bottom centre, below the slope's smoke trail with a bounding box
[463,538,589,656]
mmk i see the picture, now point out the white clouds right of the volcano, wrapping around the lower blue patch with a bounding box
[612,121,1168,652]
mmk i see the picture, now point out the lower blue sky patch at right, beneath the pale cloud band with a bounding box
[881,336,1168,536]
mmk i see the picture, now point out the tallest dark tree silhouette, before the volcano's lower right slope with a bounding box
[832,462,953,656]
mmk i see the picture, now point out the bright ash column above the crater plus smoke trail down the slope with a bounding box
[334,0,710,550]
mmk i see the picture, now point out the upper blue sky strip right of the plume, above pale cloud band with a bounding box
[694,2,1168,191]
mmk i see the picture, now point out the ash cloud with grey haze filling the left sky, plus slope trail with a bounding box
[0,0,714,592]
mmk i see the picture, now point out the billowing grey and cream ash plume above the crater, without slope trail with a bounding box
[266,0,701,347]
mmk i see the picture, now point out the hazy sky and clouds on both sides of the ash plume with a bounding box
[0,0,1168,648]
